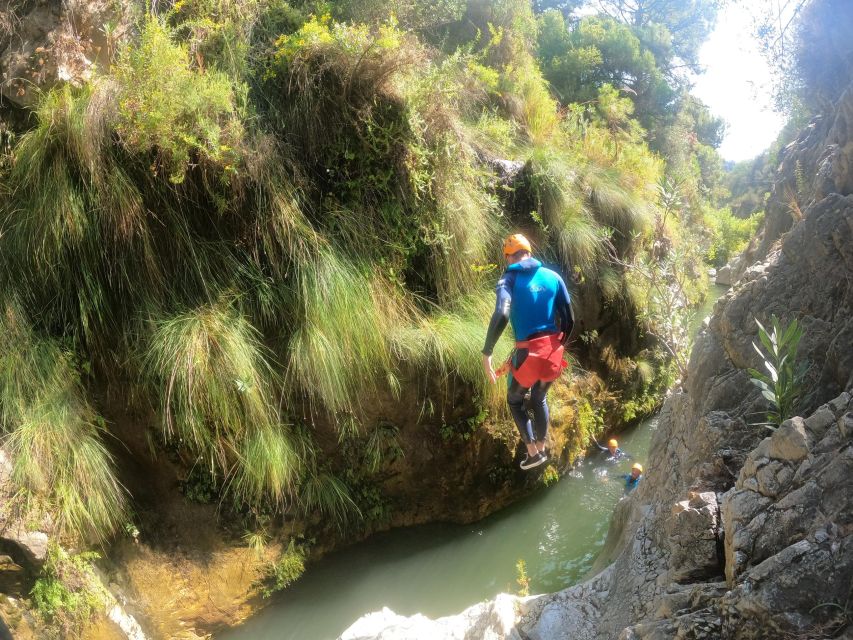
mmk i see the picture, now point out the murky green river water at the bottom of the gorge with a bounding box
[219,287,725,640]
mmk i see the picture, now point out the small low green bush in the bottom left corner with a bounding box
[30,543,106,637]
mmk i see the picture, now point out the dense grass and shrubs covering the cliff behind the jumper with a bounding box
[0,0,723,579]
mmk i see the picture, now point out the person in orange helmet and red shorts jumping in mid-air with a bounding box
[483,233,574,469]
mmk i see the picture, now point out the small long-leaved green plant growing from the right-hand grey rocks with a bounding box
[749,315,806,426]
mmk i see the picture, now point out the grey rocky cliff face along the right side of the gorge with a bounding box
[343,91,853,640]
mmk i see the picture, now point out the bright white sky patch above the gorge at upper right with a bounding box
[692,5,785,161]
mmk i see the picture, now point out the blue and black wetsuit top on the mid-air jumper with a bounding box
[483,258,574,355]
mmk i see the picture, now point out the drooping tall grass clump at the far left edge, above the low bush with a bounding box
[0,302,129,540]
